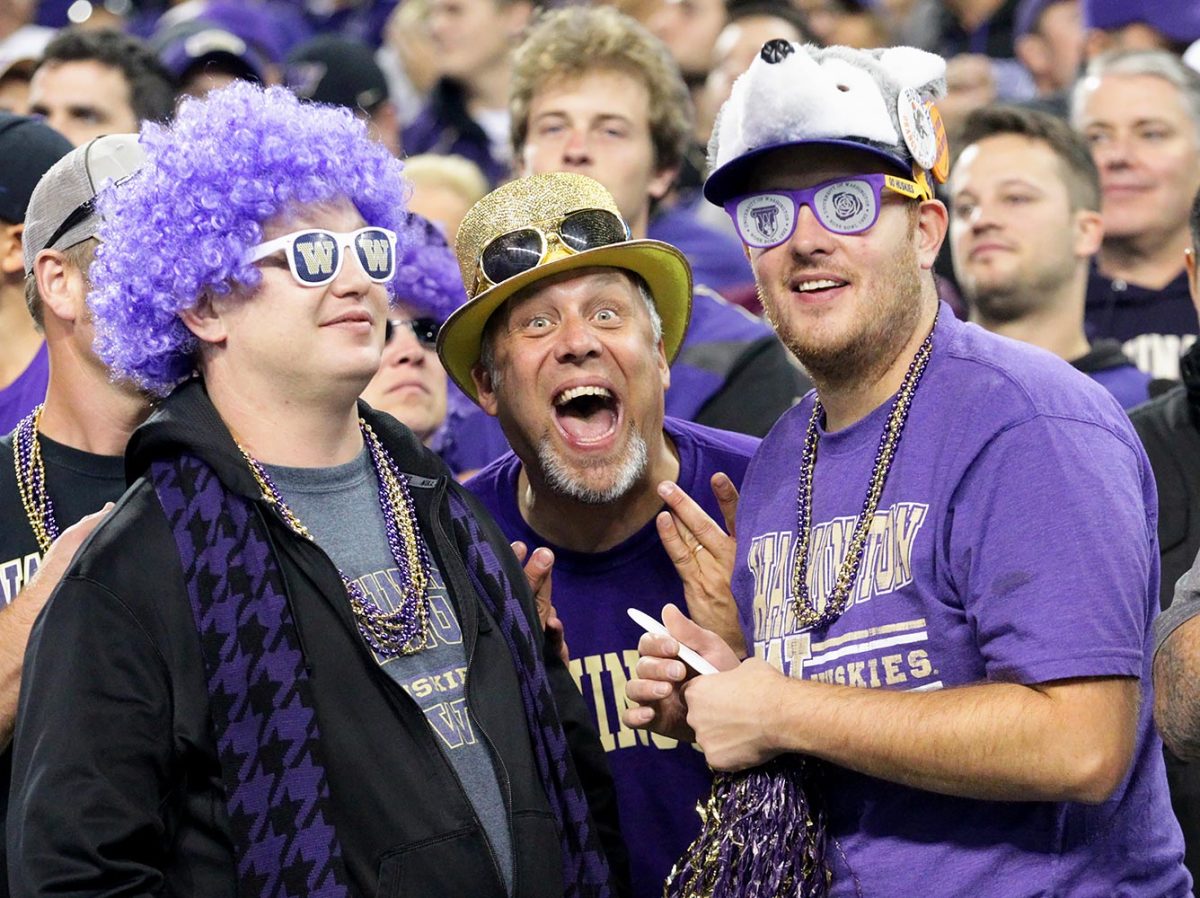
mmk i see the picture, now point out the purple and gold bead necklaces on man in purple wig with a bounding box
[238,418,431,658]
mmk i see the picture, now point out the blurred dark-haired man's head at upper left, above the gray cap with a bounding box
[29,29,175,146]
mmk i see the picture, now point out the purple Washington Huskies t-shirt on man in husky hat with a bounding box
[733,306,1190,898]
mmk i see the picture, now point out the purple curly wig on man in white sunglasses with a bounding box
[89,82,419,395]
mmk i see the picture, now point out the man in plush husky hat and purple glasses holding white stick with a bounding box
[625,41,1190,898]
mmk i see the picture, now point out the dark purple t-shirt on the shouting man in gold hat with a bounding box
[467,418,758,898]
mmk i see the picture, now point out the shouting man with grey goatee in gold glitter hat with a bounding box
[439,173,758,898]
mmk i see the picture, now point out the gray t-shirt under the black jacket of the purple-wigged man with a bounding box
[268,448,512,894]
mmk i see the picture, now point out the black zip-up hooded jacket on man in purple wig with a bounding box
[8,382,625,898]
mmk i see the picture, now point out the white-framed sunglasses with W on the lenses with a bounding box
[247,227,396,287]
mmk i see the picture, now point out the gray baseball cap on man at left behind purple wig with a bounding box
[23,134,145,274]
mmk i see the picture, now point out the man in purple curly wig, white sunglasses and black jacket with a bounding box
[8,83,620,898]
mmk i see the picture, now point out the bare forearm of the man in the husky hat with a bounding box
[768,678,1138,802]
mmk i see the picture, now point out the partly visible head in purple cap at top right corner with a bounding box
[1082,0,1200,59]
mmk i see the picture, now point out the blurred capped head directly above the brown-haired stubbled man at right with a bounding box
[1015,0,1084,119]
